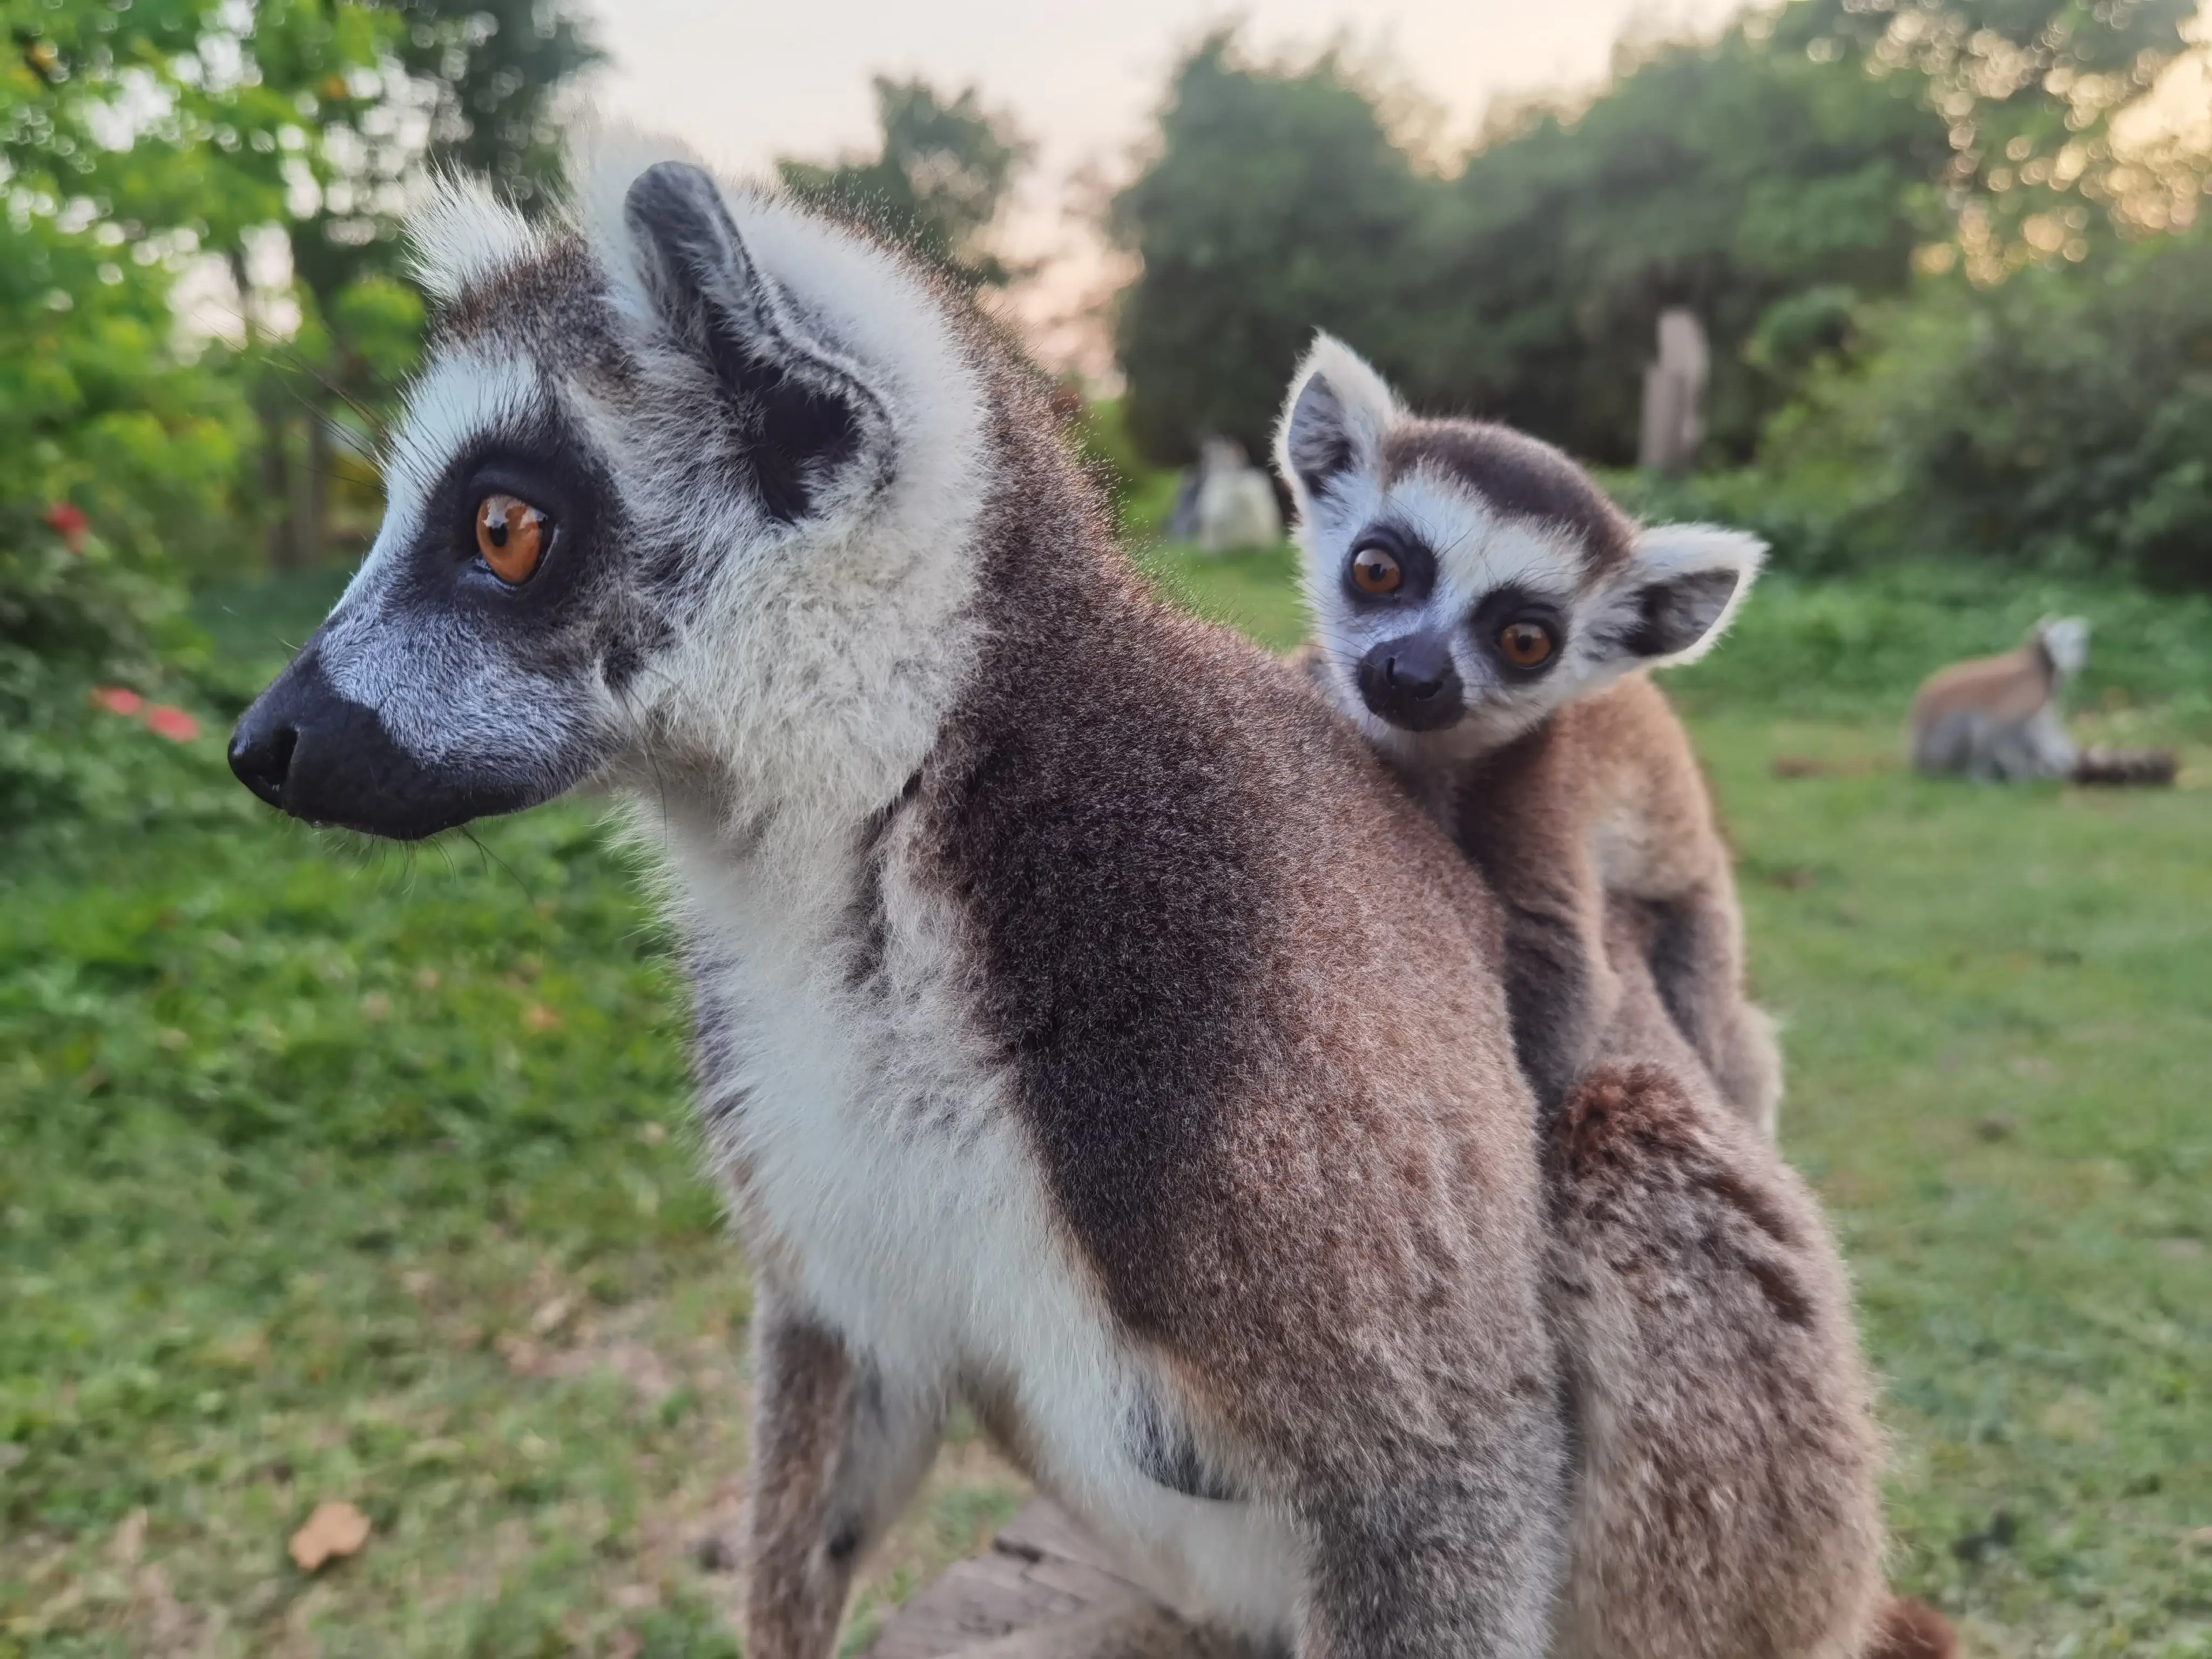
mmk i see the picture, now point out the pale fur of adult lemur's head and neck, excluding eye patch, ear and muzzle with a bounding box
[307,133,991,858]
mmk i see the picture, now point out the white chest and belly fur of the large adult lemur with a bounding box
[677,818,1298,1637]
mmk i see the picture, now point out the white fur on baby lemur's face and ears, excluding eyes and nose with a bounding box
[1276,334,1765,759]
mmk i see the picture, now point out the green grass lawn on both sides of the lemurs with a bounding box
[0,555,2212,1659]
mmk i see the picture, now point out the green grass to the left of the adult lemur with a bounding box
[0,573,1020,1659]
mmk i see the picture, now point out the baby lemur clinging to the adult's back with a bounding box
[1276,336,1781,1132]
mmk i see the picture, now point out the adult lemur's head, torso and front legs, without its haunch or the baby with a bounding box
[220,157,1871,1659]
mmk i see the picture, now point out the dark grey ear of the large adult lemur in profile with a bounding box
[622,161,885,524]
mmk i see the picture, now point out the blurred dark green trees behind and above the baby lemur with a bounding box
[1112,0,2198,464]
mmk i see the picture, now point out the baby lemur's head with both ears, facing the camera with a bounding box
[1276,336,1763,752]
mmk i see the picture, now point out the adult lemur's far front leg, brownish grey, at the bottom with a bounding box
[745,1283,942,1659]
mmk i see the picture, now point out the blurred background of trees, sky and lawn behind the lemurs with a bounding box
[0,0,2212,1659]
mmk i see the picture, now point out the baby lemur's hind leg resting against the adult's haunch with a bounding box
[1650,882,1783,1137]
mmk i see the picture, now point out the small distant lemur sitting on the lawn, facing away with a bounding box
[1907,617,2174,783]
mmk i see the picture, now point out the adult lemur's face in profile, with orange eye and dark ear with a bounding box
[230,161,915,838]
